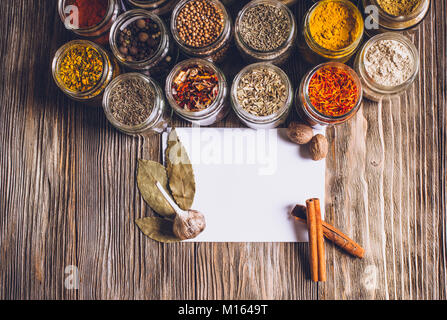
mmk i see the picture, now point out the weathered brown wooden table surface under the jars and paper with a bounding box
[0,0,447,299]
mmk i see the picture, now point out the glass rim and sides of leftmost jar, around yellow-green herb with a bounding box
[52,40,120,105]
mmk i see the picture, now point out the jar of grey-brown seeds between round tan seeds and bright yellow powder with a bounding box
[235,0,297,64]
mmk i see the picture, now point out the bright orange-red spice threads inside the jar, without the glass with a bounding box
[308,66,359,117]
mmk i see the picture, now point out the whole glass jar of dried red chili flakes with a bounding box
[165,59,230,126]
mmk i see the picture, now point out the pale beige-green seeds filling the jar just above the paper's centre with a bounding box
[237,67,287,117]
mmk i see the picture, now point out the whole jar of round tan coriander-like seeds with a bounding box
[171,0,233,62]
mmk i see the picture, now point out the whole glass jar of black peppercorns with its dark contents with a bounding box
[110,9,178,78]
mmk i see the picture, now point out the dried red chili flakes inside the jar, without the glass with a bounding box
[172,64,219,112]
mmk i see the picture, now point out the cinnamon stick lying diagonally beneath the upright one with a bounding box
[292,205,365,259]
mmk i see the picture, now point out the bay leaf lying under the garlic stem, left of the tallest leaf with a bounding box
[137,159,175,219]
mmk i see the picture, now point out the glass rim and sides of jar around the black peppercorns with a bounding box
[110,9,178,78]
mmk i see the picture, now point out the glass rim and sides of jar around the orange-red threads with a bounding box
[295,62,362,129]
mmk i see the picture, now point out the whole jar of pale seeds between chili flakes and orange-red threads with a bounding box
[231,62,293,129]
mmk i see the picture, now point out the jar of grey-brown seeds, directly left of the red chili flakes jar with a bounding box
[102,73,169,136]
